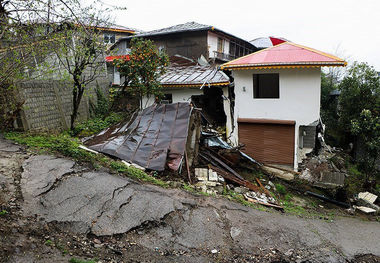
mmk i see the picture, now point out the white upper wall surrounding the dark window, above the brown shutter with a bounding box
[227,68,321,168]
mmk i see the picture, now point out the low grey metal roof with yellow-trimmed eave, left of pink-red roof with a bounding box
[159,65,230,87]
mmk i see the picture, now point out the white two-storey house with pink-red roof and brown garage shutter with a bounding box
[221,42,347,169]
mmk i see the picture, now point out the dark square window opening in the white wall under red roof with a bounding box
[253,73,280,99]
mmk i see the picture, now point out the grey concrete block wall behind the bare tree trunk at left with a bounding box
[16,79,109,130]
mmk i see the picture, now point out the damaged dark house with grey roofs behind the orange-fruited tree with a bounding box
[106,22,258,126]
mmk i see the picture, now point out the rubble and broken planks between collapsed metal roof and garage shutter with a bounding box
[195,132,283,210]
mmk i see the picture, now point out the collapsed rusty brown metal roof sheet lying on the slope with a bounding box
[85,102,192,171]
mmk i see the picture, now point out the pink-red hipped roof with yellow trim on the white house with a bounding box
[221,42,347,69]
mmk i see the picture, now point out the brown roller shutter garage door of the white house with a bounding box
[238,119,295,167]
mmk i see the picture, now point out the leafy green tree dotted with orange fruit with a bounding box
[114,38,169,106]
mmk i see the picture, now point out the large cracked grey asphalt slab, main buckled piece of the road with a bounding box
[40,173,183,236]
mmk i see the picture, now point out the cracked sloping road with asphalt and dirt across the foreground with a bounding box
[0,139,380,262]
